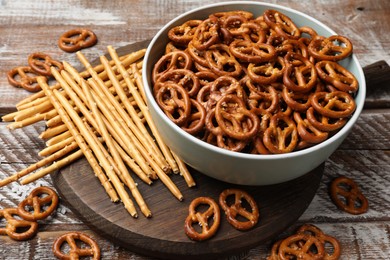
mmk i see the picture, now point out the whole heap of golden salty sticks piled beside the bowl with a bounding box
[0,46,195,217]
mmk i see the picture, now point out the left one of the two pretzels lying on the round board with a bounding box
[184,197,221,241]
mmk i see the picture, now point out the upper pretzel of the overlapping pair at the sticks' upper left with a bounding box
[28,52,64,76]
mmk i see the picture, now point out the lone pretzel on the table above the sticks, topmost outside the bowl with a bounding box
[58,28,97,52]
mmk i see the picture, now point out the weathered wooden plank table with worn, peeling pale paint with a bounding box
[0,0,390,259]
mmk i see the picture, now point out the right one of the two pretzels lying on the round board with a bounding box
[219,189,260,230]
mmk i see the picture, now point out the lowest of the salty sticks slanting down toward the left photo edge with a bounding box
[20,150,84,185]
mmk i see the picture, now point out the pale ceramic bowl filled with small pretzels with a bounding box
[143,1,366,185]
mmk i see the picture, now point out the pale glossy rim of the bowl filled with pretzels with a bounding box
[142,1,366,160]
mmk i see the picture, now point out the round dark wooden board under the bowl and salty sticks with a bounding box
[52,41,324,259]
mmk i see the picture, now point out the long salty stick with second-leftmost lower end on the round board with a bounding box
[53,90,138,217]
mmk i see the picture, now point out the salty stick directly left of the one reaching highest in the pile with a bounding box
[100,54,170,172]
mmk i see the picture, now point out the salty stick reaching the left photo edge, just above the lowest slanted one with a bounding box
[0,142,78,187]
